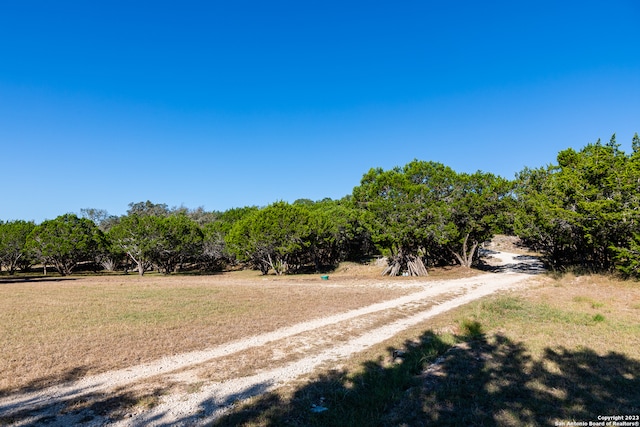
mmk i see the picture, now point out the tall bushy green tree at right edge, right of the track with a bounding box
[515,135,640,271]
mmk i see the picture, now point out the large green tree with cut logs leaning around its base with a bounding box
[353,160,456,275]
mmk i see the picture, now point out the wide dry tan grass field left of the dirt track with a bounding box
[0,263,472,393]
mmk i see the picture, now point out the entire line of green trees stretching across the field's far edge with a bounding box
[0,134,640,277]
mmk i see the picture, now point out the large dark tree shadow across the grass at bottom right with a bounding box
[213,332,640,426]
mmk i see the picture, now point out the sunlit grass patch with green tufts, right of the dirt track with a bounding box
[464,275,640,356]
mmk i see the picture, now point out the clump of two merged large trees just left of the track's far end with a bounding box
[353,160,511,275]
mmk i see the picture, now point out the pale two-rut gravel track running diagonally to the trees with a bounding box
[0,252,538,427]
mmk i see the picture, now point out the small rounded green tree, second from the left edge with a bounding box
[29,214,104,276]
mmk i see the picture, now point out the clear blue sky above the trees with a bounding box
[0,0,640,222]
